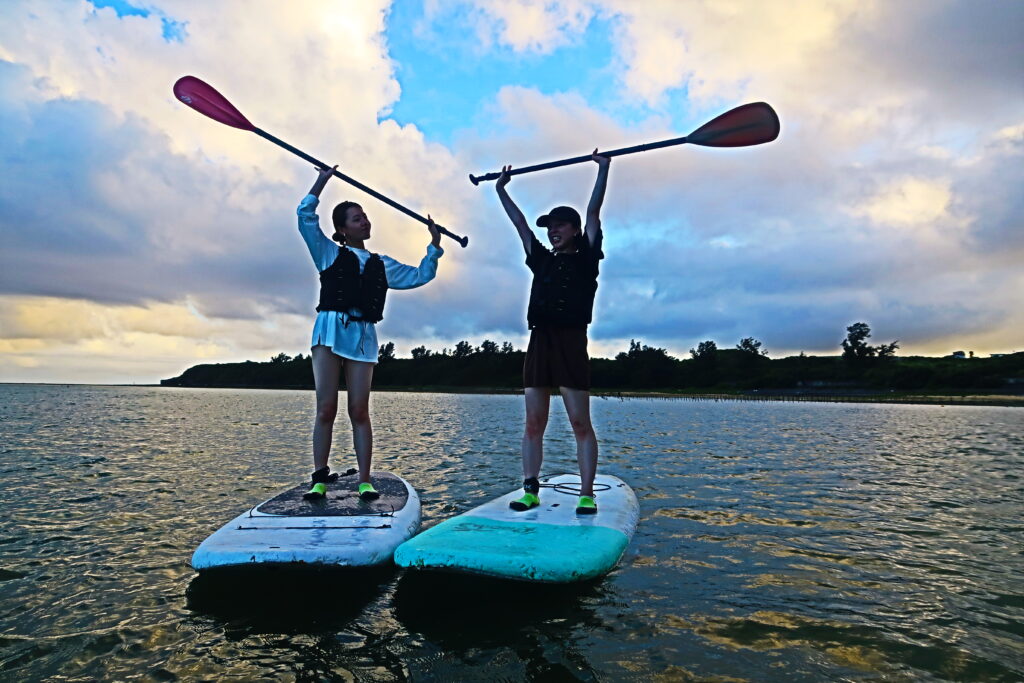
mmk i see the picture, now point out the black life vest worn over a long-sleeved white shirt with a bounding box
[316,247,387,323]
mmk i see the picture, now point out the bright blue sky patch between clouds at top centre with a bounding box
[385,2,738,147]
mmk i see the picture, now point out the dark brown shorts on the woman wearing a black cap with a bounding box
[522,328,590,390]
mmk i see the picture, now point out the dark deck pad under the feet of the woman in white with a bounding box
[256,472,409,517]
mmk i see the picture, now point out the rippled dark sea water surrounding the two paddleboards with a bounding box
[0,385,1024,681]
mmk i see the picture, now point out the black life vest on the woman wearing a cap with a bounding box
[526,237,604,329]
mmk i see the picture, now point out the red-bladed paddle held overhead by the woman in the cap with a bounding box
[469,102,779,185]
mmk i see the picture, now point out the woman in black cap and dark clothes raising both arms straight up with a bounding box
[496,150,611,514]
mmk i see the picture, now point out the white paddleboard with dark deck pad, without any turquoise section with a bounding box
[191,472,420,571]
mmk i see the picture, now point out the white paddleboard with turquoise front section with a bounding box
[394,474,640,584]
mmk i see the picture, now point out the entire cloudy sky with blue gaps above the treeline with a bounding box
[0,0,1024,383]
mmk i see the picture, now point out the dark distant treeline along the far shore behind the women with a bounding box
[161,323,1024,393]
